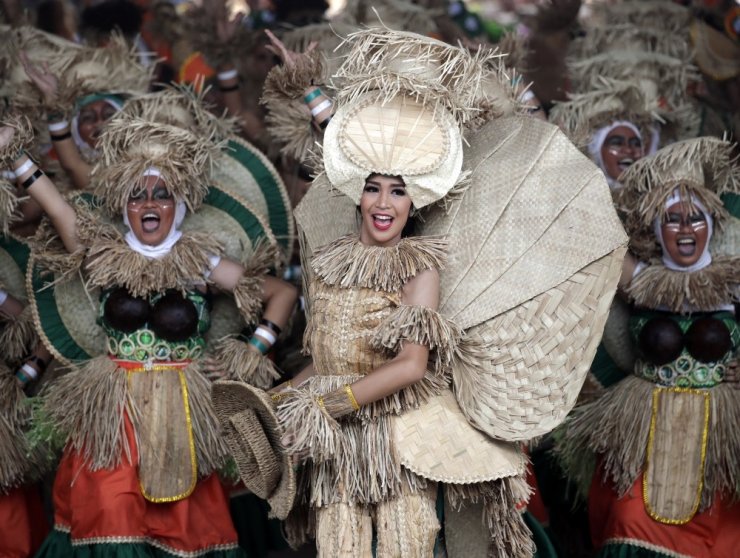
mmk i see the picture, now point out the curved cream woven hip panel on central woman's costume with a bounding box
[392,390,526,484]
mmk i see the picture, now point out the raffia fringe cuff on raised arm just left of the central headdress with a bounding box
[261,52,329,162]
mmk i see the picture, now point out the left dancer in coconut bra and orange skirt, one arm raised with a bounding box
[0,85,296,557]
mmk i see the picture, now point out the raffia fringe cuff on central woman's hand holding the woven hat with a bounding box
[277,388,345,463]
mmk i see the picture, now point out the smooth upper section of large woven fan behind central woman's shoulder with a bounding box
[422,117,627,329]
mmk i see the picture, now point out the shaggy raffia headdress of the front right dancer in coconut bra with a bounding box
[617,137,740,261]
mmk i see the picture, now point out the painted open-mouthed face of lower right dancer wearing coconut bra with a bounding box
[660,202,709,267]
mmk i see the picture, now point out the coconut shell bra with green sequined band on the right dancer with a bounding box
[630,311,740,388]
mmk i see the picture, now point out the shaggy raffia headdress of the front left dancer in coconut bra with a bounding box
[92,89,228,215]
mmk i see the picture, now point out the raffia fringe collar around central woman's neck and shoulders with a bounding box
[311,235,447,292]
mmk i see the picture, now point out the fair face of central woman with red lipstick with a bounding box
[360,174,411,246]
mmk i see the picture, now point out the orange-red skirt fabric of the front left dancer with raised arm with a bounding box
[54,416,237,552]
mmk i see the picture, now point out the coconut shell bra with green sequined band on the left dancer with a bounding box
[98,287,211,362]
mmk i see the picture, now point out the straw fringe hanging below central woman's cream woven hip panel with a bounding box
[445,477,535,558]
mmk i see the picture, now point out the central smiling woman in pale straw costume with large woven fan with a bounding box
[213,29,625,558]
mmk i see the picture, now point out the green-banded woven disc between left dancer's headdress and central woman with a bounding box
[211,136,295,259]
